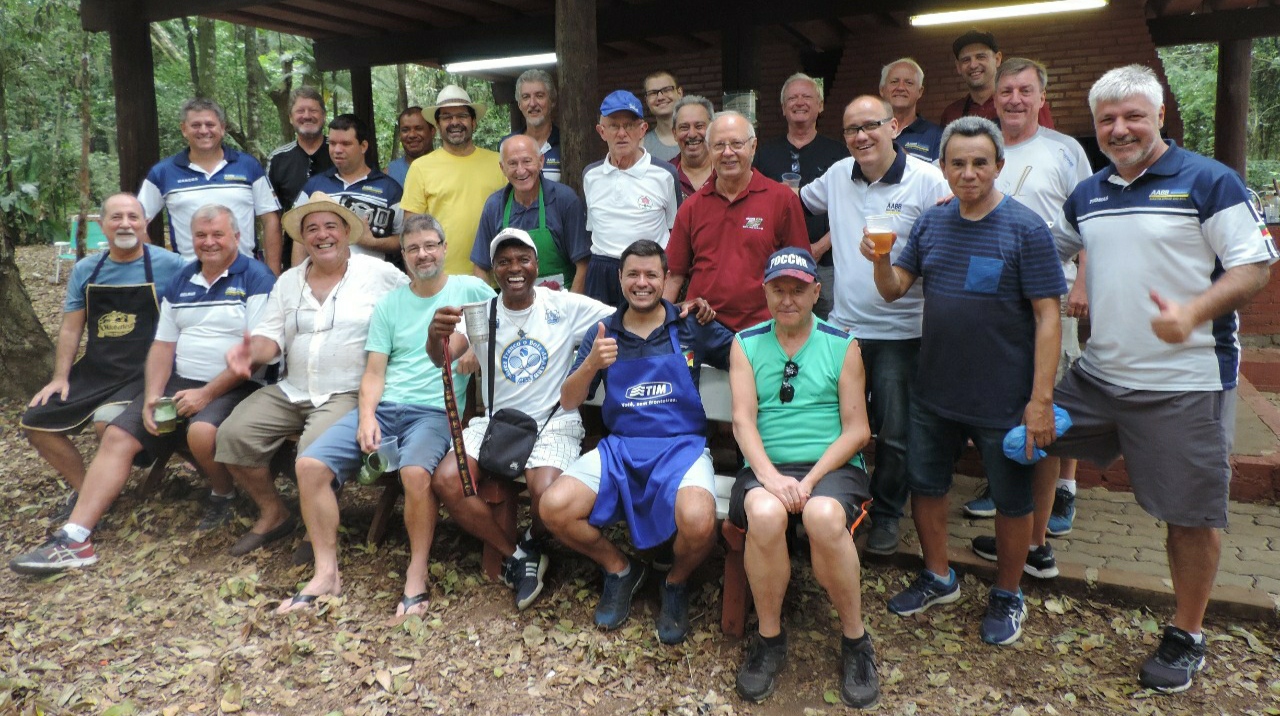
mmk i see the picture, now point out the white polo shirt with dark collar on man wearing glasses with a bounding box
[800,143,951,341]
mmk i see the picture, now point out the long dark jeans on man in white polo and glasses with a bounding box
[858,338,920,521]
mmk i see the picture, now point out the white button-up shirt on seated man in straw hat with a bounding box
[253,255,408,407]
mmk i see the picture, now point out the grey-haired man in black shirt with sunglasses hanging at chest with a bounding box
[755,72,849,320]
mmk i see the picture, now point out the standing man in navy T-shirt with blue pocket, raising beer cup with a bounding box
[861,117,1066,646]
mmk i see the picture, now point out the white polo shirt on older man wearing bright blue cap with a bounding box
[582,151,680,259]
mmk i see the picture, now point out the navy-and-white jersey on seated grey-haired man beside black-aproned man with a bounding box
[156,255,275,382]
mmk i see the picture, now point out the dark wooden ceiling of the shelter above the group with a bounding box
[81,0,1280,69]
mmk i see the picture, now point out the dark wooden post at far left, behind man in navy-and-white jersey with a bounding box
[109,3,162,246]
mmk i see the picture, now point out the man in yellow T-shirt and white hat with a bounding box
[401,85,507,275]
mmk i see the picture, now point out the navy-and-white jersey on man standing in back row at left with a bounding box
[138,146,280,261]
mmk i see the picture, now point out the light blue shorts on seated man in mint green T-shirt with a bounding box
[298,402,449,489]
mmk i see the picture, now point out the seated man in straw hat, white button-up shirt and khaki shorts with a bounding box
[216,192,408,556]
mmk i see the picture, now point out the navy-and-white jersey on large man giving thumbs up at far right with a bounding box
[1059,142,1277,391]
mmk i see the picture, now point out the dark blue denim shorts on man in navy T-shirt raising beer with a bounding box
[906,398,1036,517]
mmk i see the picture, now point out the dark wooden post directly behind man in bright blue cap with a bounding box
[556,0,593,196]
